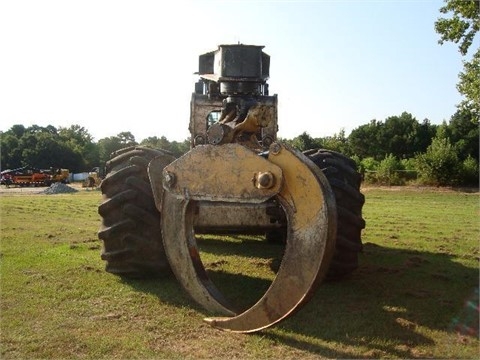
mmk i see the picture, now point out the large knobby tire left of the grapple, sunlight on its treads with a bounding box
[98,146,175,278]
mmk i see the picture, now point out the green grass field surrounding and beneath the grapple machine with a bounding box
[0,188,480,359]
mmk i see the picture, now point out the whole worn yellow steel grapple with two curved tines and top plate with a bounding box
[148,143,337,333]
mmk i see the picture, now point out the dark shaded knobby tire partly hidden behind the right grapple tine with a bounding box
[304,149,365,280]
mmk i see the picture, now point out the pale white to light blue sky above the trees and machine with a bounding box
[0,0,462,141]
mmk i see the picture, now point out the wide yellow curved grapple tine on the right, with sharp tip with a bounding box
[205,145,336,333]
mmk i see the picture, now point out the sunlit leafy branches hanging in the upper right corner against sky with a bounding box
[435,0,480,119]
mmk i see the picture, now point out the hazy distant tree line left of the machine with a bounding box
[0,125,190,173]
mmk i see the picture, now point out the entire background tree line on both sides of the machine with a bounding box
[0,109,479,186]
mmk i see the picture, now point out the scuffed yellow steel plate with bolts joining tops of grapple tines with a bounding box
[159,144,282,203]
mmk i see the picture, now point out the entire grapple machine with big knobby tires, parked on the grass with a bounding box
[98,44,365,332]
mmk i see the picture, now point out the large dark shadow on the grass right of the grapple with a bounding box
[269,243,479,358]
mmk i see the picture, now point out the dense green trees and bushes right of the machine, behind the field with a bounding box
[287,109,479,186]
